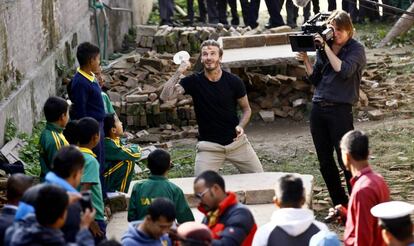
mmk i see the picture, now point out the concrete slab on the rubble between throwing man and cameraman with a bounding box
[221,44,315,68]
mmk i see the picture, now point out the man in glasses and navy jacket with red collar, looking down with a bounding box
[194,170,257,246]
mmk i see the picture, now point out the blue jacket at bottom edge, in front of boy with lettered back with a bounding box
[122,221,172,246]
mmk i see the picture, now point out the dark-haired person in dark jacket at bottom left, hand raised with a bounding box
[10,185,95,246]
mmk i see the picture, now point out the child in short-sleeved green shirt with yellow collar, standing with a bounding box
[76,117,106,244]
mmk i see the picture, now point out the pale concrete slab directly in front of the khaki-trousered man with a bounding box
[128,172,314,207]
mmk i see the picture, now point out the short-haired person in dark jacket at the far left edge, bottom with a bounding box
[0,173,33,242]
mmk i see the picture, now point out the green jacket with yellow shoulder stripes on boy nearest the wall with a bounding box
[39,122,69,180]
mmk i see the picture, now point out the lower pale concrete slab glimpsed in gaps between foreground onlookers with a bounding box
[106,204,276,241]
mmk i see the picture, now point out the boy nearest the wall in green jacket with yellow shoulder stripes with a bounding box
[39,97,69,181]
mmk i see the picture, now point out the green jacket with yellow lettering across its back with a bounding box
[128,175,194,224]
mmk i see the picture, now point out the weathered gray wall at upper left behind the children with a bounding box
[0,0,152,146]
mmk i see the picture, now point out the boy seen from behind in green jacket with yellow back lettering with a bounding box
[128,149,194,224]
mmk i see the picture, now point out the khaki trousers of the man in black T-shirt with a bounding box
[194,134,263,176]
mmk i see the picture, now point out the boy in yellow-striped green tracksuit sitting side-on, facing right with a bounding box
[103,114,141,192]
